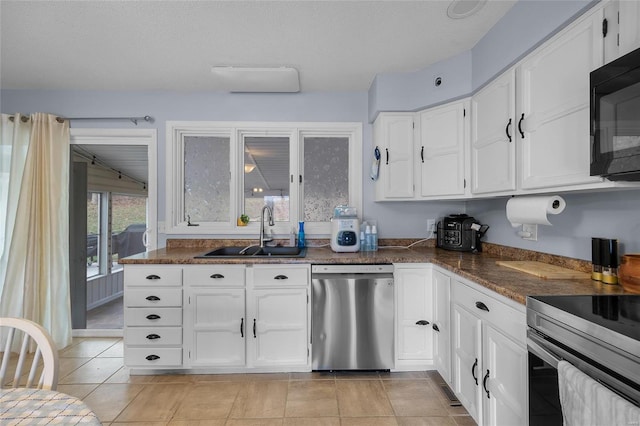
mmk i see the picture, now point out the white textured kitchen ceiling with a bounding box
[0,0,516,92]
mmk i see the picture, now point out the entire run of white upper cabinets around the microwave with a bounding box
[374,0,640,201]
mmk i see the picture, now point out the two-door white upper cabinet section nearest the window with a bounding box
[373,99,469,201]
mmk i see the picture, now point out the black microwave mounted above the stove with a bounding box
[590,45,640,181]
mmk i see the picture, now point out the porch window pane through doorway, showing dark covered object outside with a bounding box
[111,194,147,270]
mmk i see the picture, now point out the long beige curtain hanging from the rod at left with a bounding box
[0,113,71,348]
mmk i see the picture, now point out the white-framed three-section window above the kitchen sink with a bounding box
[166,122,362,236]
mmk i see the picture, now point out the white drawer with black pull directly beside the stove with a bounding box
[453,280,526,343]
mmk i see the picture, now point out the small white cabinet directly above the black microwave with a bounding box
[604,0,640,63]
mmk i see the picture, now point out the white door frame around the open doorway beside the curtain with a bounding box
[69,128,158,337]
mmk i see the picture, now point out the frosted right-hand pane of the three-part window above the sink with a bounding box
[303,137,349,222]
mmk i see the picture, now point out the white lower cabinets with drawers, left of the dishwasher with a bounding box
[124,264,311,374]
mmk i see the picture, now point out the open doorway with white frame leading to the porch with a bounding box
[70,129,157,336]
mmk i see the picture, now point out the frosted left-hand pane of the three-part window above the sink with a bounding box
[183,136,231,223]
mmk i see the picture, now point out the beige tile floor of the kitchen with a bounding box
[58,338,475,426]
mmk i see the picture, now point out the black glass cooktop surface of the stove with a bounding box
[529,294,640,340]
